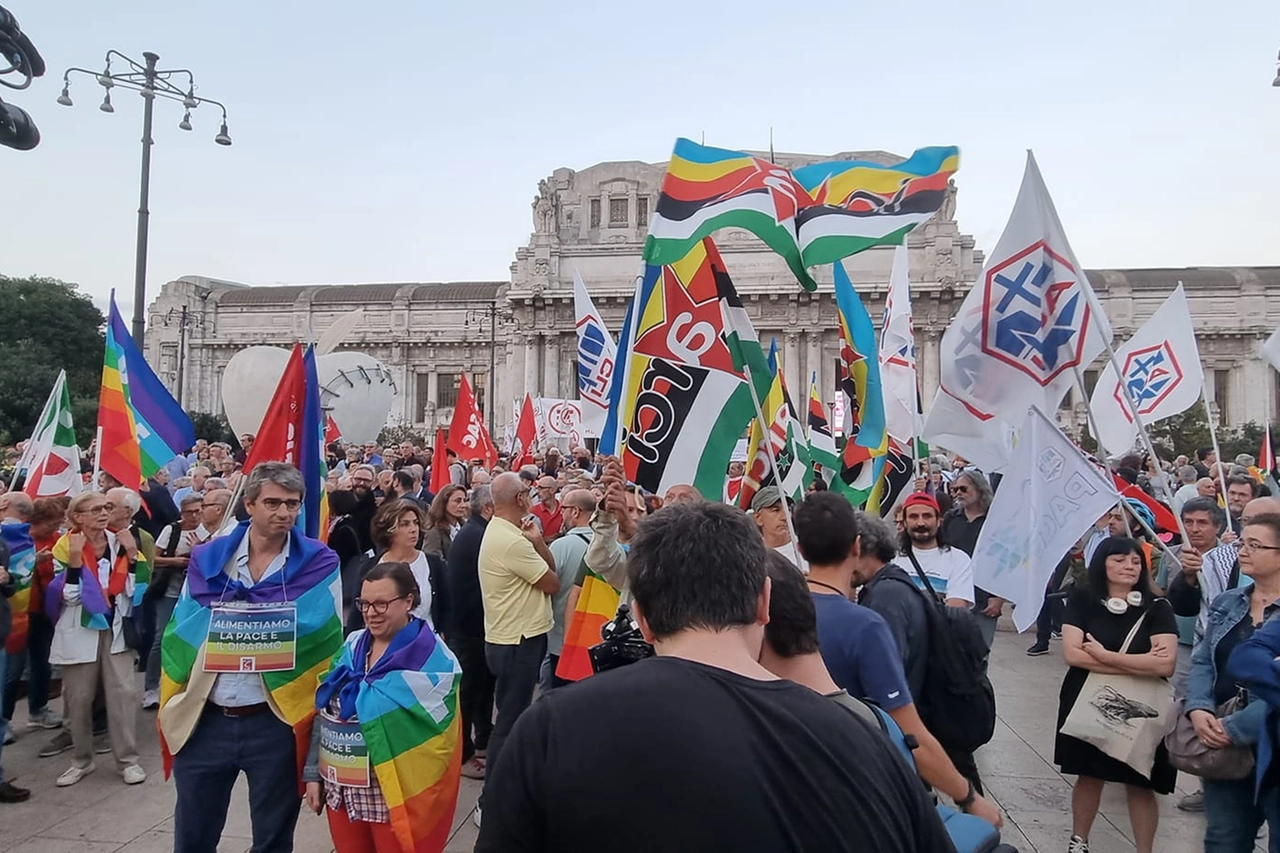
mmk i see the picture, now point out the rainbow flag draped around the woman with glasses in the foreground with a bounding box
[315,619,462,853]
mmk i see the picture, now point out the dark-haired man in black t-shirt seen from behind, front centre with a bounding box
[476,502,954,853]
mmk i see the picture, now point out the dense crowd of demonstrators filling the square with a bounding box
[0,435,1280,853]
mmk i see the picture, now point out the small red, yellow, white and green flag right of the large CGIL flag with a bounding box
[737,341,813,510]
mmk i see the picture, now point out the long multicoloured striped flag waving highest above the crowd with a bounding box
[644,140,960,291]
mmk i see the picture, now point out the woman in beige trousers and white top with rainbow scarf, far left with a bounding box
[45,492,147,788]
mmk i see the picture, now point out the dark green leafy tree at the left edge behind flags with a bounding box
[0,274,106,447]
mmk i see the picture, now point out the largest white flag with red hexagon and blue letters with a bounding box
[924,151,1111,468]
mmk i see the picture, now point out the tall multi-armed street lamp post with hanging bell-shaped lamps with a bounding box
[58,50,232,350]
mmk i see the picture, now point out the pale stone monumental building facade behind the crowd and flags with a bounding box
[147,151,1280,445]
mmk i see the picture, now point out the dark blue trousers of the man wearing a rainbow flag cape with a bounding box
[173,708,302,853]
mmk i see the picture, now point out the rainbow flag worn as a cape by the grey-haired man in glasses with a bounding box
[160,521,342,776]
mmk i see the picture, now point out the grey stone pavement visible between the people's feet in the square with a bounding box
[0,631,1249,853]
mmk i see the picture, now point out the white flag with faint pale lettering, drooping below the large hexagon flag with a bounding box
[973,407,1120,631]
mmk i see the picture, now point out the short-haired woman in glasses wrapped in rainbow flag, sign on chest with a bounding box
[302,562,462,853]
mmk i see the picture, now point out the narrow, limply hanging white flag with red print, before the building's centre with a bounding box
[879,246,920,444]
